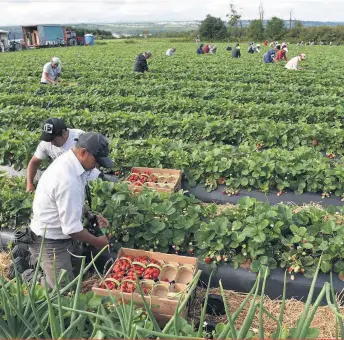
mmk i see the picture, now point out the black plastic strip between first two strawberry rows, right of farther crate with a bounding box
[182,179,344,206]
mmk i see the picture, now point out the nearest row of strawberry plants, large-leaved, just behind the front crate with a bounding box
[0,175,344,276]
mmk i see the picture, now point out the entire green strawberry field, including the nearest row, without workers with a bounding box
[0,40,344,277]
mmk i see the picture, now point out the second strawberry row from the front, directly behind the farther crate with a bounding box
[0,130,344,196]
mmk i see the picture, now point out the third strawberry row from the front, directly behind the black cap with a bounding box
[0,109,344,154]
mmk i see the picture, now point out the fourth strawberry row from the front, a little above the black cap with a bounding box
[0,88,344,123]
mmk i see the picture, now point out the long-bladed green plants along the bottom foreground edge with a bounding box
[0,235,344,339]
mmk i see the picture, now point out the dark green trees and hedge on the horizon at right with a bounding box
[198,5,344,43]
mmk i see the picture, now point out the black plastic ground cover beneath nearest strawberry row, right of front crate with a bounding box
[199,264,344,305]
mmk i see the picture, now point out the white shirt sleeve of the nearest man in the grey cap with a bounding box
[55,183,84,235]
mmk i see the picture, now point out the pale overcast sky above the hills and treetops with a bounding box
[0,0,344,26]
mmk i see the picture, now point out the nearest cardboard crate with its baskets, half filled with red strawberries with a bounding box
[92,248,198,319]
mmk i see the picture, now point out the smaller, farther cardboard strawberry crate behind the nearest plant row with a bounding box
[126,167,182,192]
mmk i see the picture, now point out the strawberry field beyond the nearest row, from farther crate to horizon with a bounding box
[0,40,344,198]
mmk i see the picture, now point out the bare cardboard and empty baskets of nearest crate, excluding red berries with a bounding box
[92,248,198,323]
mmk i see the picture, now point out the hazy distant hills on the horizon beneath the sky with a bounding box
[0,20,344,39]
